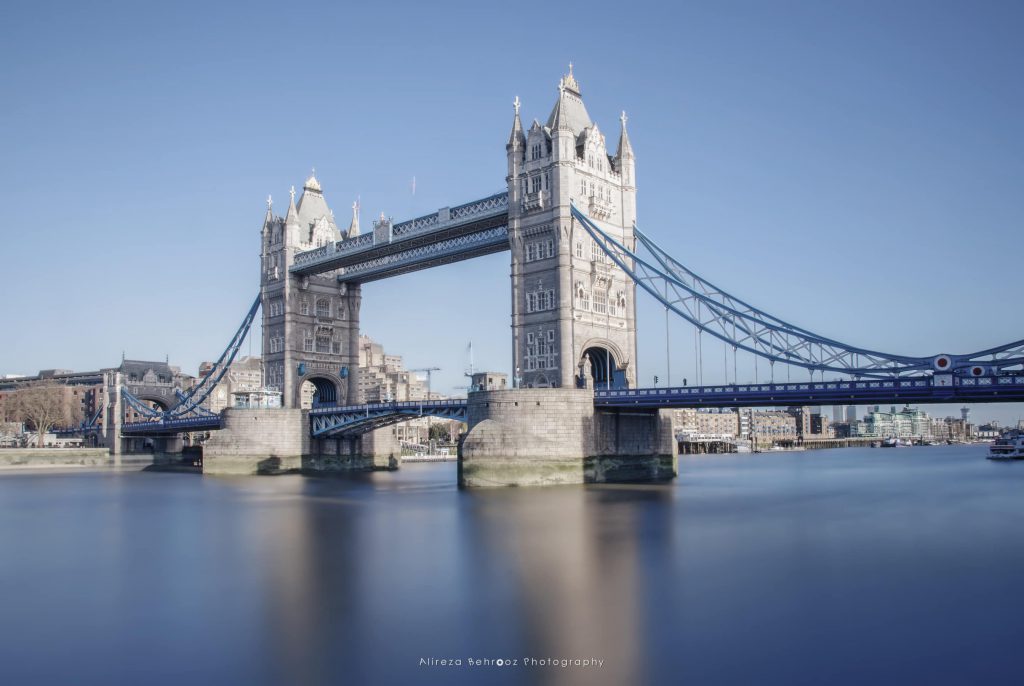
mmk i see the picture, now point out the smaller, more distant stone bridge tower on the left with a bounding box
[260,174,361,409]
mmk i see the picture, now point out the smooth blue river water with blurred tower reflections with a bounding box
[0,446,1024,685]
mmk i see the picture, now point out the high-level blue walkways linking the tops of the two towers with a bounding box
[289,192,508,283]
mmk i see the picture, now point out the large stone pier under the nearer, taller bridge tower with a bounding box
[459,388,678,488]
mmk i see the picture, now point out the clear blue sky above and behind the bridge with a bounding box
[0,1,1024,421]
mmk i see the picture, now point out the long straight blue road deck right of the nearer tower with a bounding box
[594,374,1024,408]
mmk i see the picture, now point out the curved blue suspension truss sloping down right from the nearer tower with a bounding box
[571,205,1024,378]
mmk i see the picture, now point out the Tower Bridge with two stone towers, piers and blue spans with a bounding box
[108,69,1024,486]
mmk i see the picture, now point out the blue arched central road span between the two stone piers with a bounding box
[309,398,466,438]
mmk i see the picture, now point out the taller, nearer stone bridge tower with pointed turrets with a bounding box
[506,70,637,395]
